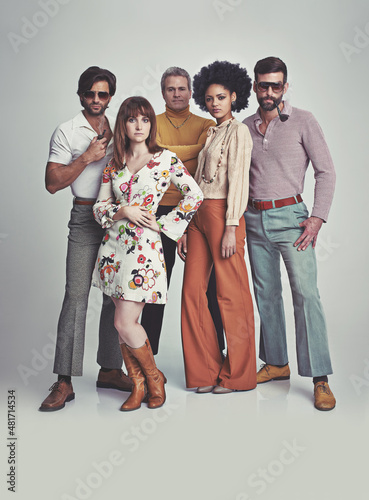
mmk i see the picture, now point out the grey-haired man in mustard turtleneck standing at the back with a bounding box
[141,67,224,354]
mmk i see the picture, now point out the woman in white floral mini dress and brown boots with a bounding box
[92,97,203,411]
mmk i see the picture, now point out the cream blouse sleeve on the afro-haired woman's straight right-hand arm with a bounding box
[226,124,252,226]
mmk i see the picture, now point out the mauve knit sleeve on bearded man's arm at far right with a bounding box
[302,114,336,222]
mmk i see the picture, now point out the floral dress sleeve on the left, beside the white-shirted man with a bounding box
[93,160,120,228]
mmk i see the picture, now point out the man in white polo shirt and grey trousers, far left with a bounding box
[40,66,132,411]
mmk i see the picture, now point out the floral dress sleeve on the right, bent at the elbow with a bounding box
[157,154,204,241]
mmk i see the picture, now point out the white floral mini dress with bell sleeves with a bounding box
[92,149,203,304]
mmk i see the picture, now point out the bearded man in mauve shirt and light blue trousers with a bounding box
[244,57,336,410]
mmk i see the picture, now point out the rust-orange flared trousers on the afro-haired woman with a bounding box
[181,200,256,391]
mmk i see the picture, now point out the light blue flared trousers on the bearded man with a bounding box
[245,203,332,377]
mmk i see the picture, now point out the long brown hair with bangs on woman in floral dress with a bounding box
[113,96,163,168]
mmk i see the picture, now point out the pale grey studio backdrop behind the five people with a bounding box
[0,0,369,499]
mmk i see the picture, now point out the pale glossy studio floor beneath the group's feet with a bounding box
[3,308,369,500]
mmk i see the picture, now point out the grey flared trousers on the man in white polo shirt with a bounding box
[54,205,122,376]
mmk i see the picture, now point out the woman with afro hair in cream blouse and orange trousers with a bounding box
[178,61,256,394]
